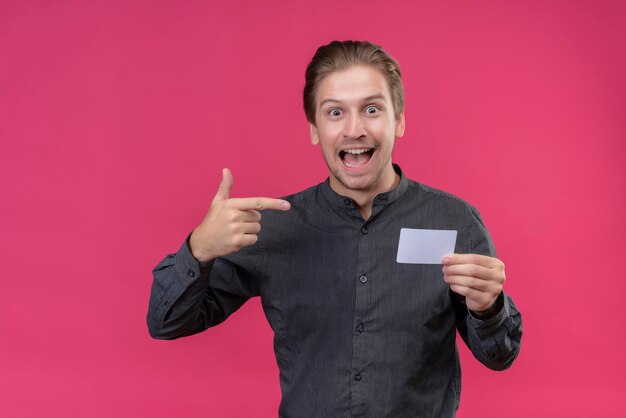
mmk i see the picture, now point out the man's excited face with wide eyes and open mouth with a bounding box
[310,66,404,195]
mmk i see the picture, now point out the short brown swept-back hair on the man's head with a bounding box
[304,41,404,124]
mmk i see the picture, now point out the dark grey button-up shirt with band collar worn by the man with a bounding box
[148,166,522,418]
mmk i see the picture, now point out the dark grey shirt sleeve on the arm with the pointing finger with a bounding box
[147,235,258,340]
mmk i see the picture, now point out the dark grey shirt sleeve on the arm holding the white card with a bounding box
[453,208,522,370]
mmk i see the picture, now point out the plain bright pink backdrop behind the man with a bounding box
[0,0,626,418]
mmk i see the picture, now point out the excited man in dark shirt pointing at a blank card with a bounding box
[148,41,522,418]
